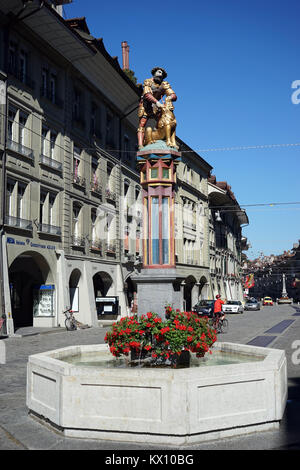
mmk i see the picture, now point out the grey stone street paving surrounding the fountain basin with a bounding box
[0,305,300,453]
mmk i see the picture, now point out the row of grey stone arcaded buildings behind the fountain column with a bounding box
[0,0,248,334]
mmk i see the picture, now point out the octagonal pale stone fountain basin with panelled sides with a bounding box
[27,342,287,445]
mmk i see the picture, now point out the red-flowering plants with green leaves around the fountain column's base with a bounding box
[105,306,217,367]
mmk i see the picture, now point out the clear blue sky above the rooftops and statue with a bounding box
[64,0,300,258]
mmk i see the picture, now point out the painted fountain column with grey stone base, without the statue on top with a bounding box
[135,141,182,317]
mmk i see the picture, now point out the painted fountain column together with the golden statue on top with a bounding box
[134,67,182,317]
